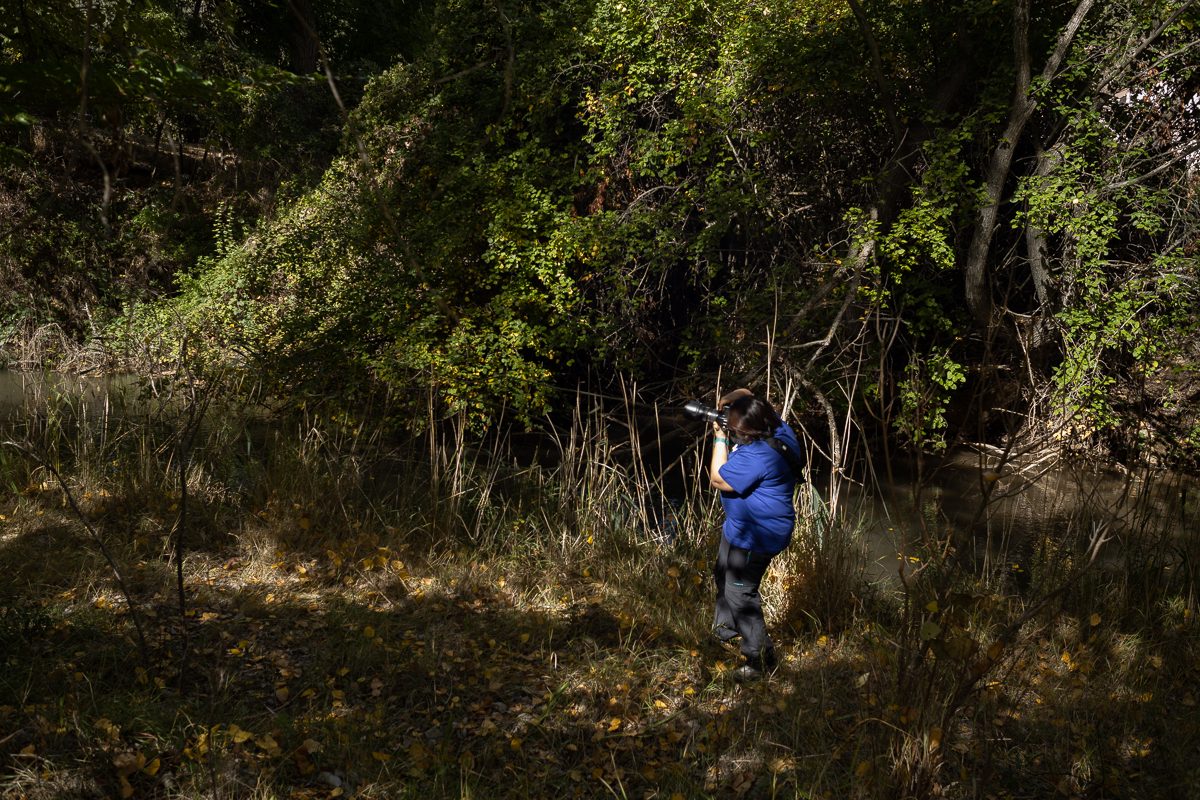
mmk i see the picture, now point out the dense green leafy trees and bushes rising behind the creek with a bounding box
[0,0,1200,453]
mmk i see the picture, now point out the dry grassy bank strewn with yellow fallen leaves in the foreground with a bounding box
[0,383,1200,799]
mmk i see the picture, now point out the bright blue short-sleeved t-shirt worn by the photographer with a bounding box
[718,421,800,554]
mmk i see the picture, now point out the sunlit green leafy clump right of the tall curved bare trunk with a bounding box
[1016,66,1195,425]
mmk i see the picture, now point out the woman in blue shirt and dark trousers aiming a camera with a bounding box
[709,389,800,680]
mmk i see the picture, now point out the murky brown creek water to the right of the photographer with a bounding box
[842,451,1200,575]
